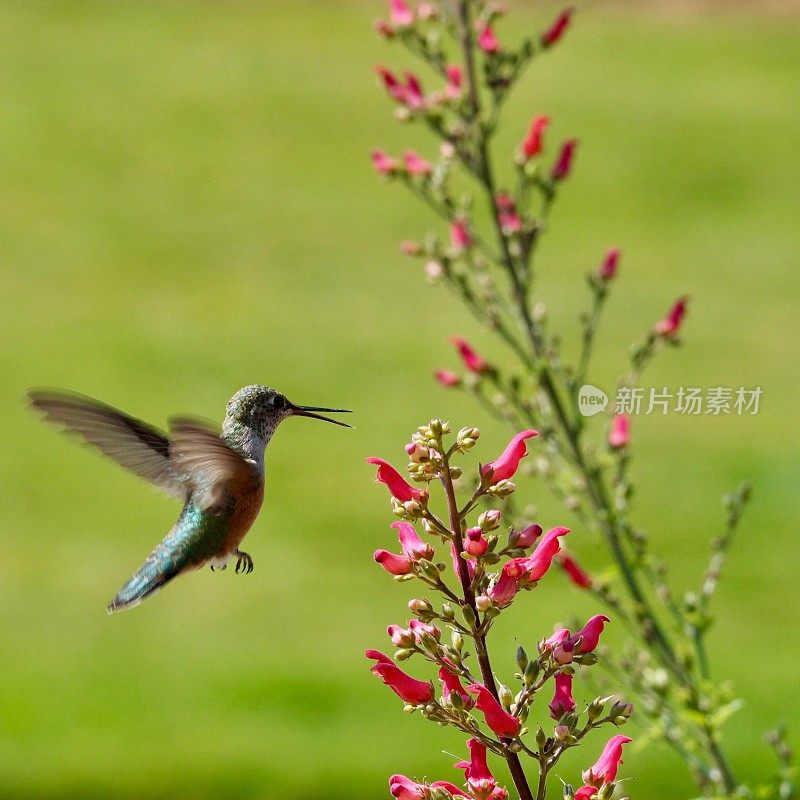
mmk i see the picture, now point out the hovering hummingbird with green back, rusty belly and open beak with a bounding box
[28,386,350,614]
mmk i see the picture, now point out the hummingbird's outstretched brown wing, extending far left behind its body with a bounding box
[28,389,189,500]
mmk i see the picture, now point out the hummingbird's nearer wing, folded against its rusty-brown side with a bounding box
[169,417,263,513]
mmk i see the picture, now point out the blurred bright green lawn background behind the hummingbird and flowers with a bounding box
[0,0,800,800]
